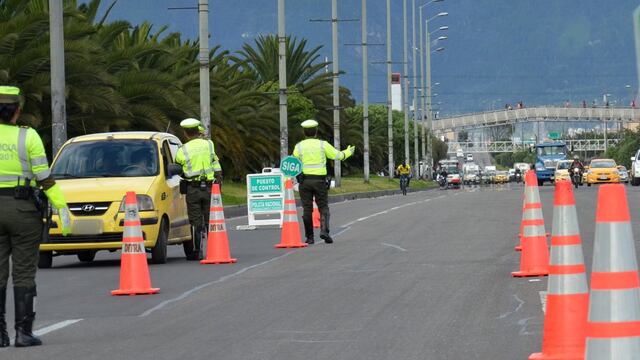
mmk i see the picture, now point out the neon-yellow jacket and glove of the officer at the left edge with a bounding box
[0,124,67,209]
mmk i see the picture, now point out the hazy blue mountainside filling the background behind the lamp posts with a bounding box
[97,0,640,117]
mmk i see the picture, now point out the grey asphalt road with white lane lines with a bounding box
[0,181,640,360]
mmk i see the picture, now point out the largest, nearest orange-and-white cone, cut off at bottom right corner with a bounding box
[586,184,640,360]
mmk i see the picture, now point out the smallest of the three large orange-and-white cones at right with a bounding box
[511,170,549,277]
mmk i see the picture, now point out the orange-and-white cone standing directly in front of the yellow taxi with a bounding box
[111,191,160,295]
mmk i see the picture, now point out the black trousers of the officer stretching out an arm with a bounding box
[299,175,329,239]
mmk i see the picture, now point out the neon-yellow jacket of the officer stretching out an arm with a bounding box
[293,139,351,175]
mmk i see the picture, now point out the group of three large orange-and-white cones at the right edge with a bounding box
[513,172,640,360]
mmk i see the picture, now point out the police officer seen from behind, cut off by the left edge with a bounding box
[0,86,71,347]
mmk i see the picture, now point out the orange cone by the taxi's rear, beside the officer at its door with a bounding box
[200,184,237,264]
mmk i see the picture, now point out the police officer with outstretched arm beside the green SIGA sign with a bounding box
[293,120,355,244]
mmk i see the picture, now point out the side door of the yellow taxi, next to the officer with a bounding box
[162,138,190,241]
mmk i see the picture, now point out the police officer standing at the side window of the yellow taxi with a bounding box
[176,119,222,260]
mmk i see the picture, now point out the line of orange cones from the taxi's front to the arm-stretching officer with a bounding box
[111,179,312,295]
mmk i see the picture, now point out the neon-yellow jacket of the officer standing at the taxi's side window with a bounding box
[176,139,222,180]
